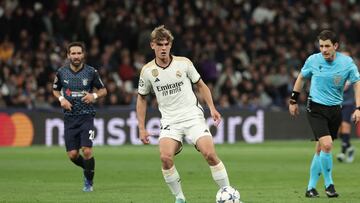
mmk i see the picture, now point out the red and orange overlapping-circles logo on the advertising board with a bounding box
[0,113,34,146]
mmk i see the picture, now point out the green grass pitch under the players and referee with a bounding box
[0,140,360,203]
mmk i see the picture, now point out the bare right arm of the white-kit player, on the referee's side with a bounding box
[196,79,221,126]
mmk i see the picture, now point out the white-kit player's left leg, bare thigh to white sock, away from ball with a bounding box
[159,135,185,203]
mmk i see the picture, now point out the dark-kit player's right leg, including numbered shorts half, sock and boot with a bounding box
[79,116,95,192]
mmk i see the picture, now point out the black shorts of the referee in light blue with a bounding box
[307,100,342,141]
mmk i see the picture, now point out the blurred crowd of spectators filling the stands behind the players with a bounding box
[0,0,360,109]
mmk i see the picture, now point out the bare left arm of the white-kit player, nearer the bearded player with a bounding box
[136,94,150,144]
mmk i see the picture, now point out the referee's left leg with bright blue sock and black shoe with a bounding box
[305,141,321,198]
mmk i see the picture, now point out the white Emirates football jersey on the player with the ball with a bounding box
[138,56,204,124]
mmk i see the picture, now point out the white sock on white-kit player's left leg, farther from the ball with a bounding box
[162,165,185,200]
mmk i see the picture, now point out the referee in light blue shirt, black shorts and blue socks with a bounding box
[289,30,360,198]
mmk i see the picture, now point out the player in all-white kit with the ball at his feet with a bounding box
[136,25,229,203]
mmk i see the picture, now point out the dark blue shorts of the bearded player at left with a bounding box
[64,115,95,151]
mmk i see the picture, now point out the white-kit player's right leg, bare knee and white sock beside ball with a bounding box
[196,136,230,187]
